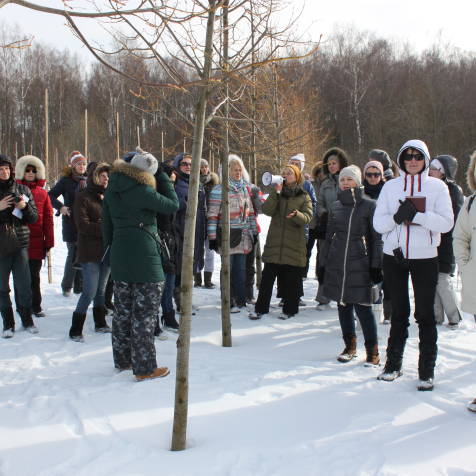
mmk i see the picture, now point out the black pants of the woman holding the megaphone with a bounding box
[255,263,302,316]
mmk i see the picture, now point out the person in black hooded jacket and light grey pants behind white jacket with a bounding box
[428,155,464,329]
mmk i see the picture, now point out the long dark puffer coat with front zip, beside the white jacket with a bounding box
[319,187,383,304]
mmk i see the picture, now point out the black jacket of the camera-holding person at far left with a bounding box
[0,175,38,248]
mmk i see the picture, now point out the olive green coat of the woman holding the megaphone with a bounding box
[263,185,312,267]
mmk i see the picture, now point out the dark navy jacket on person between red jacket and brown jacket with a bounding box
[48,167,86,243]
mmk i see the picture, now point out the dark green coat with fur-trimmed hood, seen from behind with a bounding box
[103,160,178,283]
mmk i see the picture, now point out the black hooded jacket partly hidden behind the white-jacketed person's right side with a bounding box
[435,155,464,274]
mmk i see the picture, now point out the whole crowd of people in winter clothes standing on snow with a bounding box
[0,140,476,410]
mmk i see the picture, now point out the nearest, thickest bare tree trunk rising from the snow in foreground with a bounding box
[171,0,216,451]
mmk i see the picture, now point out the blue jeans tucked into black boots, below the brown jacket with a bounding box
[75,262,111,314]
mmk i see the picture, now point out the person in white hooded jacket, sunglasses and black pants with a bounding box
[373,139,453,391]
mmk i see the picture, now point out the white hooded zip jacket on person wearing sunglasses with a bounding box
[373,140,454,259]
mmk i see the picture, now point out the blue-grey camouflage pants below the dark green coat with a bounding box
[112,281,164,375]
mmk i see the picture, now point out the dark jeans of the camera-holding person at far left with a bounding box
[0,248,31,311]
